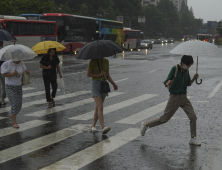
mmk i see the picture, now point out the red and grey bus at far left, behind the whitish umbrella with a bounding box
[0,15,57,48]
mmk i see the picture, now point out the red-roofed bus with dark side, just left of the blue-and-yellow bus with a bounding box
[41,13,96,52]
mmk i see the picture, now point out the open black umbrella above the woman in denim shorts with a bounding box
[76,40,123,60]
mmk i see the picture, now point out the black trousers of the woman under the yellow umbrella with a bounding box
[43,76,58,102]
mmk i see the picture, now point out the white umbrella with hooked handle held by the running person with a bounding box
[170,41,220,84]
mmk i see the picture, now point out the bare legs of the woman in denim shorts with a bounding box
[92,96,105,129]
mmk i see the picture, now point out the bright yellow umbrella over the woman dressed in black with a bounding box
[32,41,66,54]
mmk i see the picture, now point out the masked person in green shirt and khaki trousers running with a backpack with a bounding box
[140,55,201,146]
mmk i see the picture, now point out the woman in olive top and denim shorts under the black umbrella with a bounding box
[87,58,118,134]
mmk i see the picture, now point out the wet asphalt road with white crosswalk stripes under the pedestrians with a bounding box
[0,42,222,170]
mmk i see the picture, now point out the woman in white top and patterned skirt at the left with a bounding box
[1,60,30,128]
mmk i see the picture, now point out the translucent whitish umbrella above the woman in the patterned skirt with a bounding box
[0,44,37,61]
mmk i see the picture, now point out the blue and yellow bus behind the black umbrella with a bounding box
[96,18,123,47]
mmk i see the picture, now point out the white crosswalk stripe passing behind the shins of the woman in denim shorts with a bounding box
[69,94,158,120]
